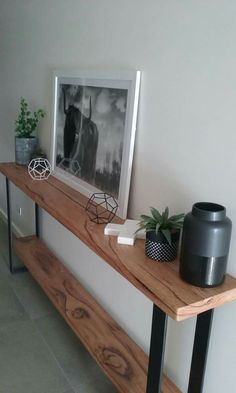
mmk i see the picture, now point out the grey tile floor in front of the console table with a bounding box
[0,216,117,393]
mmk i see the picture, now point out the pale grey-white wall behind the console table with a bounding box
[0,0,236,393]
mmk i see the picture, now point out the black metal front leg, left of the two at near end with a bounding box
[146,304,167,393]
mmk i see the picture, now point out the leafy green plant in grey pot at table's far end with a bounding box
[15,98,46,165]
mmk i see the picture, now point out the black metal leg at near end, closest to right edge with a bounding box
[188,310,214,393]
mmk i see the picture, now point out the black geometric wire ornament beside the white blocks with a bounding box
[85,192,118,224]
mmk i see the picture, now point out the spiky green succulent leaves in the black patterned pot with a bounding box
[138,207,184,244]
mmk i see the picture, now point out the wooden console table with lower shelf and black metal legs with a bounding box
[0,163,236,393]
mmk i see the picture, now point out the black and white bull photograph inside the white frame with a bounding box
[56,84,128,198]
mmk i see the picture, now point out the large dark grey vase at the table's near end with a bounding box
[180,202,232,288]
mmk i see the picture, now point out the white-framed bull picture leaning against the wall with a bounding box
[51,71,140,218]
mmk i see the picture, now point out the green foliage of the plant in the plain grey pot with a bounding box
[15,98,46,138]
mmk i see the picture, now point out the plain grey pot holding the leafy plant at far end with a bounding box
[15,137,37,165]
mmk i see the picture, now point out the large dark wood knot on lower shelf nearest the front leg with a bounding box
[102,347,133,379]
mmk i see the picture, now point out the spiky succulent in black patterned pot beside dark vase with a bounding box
[138,207,184,261]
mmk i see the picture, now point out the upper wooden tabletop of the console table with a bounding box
[0,163,236,321]
